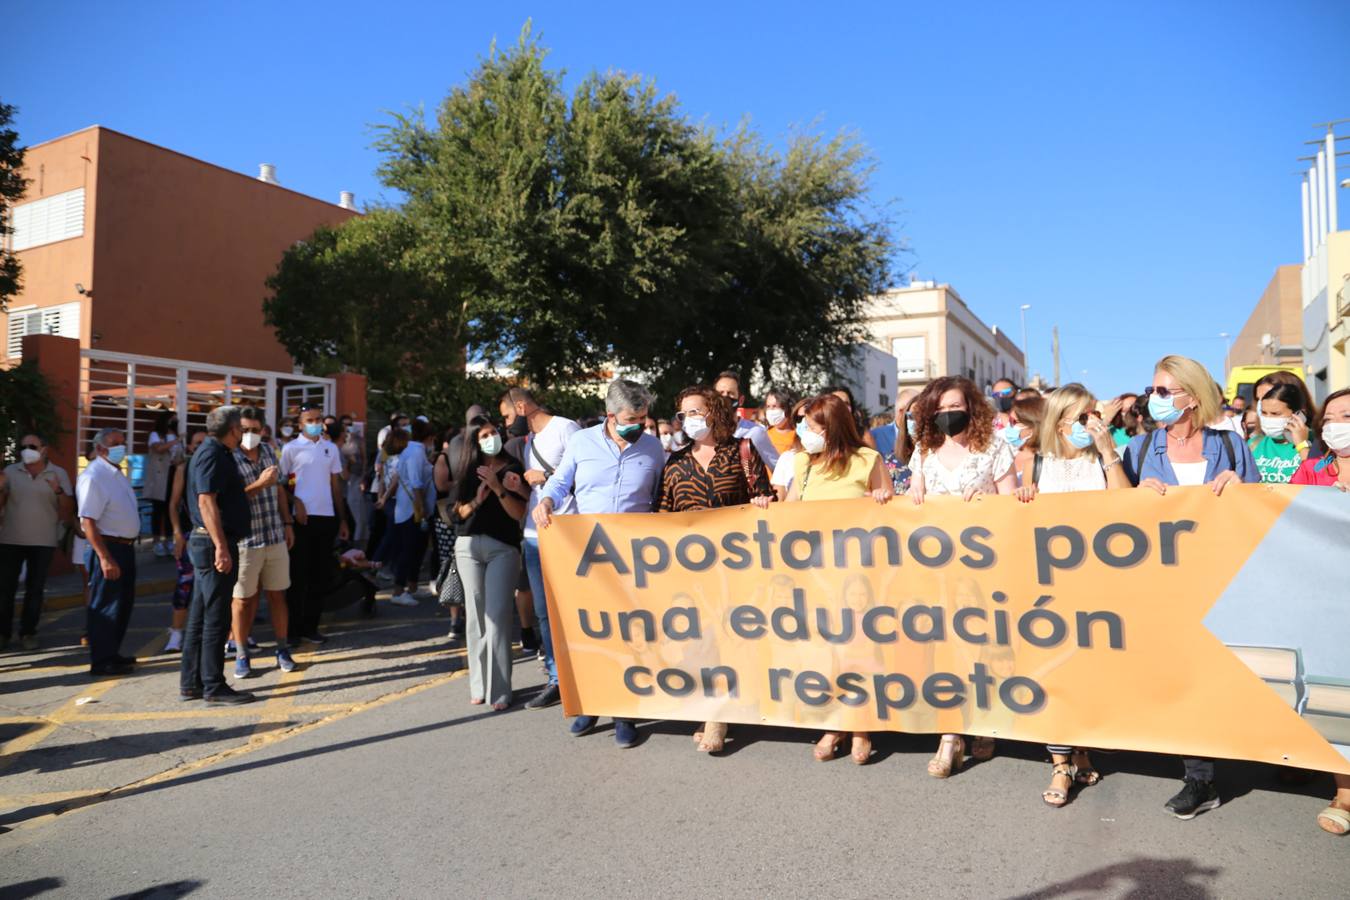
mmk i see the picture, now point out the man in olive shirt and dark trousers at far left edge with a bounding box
[0,434,76,650]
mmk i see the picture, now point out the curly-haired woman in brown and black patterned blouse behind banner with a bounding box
[657,385,774,753]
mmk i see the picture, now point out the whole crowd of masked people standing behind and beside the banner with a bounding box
[0,356,1350,834]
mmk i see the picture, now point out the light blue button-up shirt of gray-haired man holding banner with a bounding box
[543,422,664,514]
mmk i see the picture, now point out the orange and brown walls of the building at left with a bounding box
[1,127,356,372]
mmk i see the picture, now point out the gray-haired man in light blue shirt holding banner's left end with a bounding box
[533,378,666,749]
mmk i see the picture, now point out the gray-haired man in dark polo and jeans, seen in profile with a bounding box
[178,406,254,703]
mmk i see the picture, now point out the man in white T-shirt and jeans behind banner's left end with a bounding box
[504,387,581,710]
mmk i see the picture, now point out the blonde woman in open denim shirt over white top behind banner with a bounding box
[1125,356,1261,819]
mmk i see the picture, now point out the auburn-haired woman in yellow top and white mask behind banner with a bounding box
[787,394,892,765]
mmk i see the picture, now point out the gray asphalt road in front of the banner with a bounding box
[0,636,1350,900]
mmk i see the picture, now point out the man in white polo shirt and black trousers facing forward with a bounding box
[281,406,347,645]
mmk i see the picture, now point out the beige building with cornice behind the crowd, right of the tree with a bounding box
[867,281,1026,389]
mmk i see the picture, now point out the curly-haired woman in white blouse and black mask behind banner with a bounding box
[909,375,1017,779]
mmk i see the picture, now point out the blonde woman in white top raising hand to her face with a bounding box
[1017,385,1131,807]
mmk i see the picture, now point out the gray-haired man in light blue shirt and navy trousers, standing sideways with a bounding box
[76,428,140,677]
